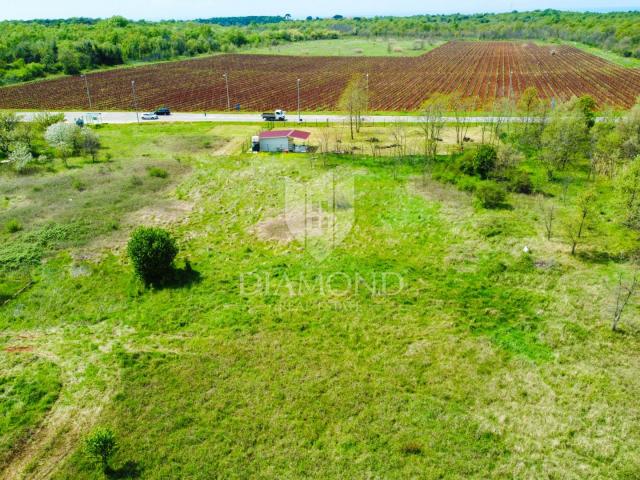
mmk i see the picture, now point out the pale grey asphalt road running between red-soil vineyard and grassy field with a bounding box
[18,112,540,126]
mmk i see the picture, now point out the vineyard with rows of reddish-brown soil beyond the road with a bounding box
[0,41,640,112]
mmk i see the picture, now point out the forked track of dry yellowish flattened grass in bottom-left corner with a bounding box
[0,325,200,480]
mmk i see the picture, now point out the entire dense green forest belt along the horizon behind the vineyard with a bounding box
[0,10,640,84]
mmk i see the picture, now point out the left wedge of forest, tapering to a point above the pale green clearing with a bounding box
[0,17,338,85]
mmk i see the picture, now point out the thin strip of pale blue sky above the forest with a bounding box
[0,0,640,20]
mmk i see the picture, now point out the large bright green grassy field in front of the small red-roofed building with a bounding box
[0,124,640,480]
